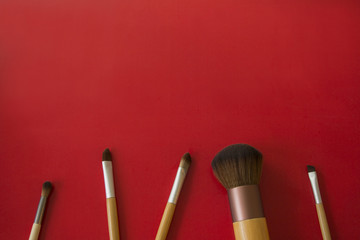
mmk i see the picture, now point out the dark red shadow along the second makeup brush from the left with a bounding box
[111,148,129,239]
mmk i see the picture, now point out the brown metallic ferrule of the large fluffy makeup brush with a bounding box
[228,185,264,222]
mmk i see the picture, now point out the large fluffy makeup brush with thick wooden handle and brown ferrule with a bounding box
[211,144,269,240]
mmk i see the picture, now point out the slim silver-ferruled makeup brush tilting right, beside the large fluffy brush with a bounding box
[155,153,191,240]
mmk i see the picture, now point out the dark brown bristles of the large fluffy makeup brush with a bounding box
[211,144,262,189]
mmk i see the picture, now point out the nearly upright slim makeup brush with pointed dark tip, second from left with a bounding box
[102,148,120,240]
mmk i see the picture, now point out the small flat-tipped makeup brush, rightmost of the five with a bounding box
[307,165,331,240]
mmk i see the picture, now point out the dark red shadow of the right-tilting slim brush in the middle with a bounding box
[164,153,197,239]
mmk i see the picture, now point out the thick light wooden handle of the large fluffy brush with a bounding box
[233,218,270,240]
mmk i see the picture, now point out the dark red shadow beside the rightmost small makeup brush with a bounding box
[316,169,339,239]
